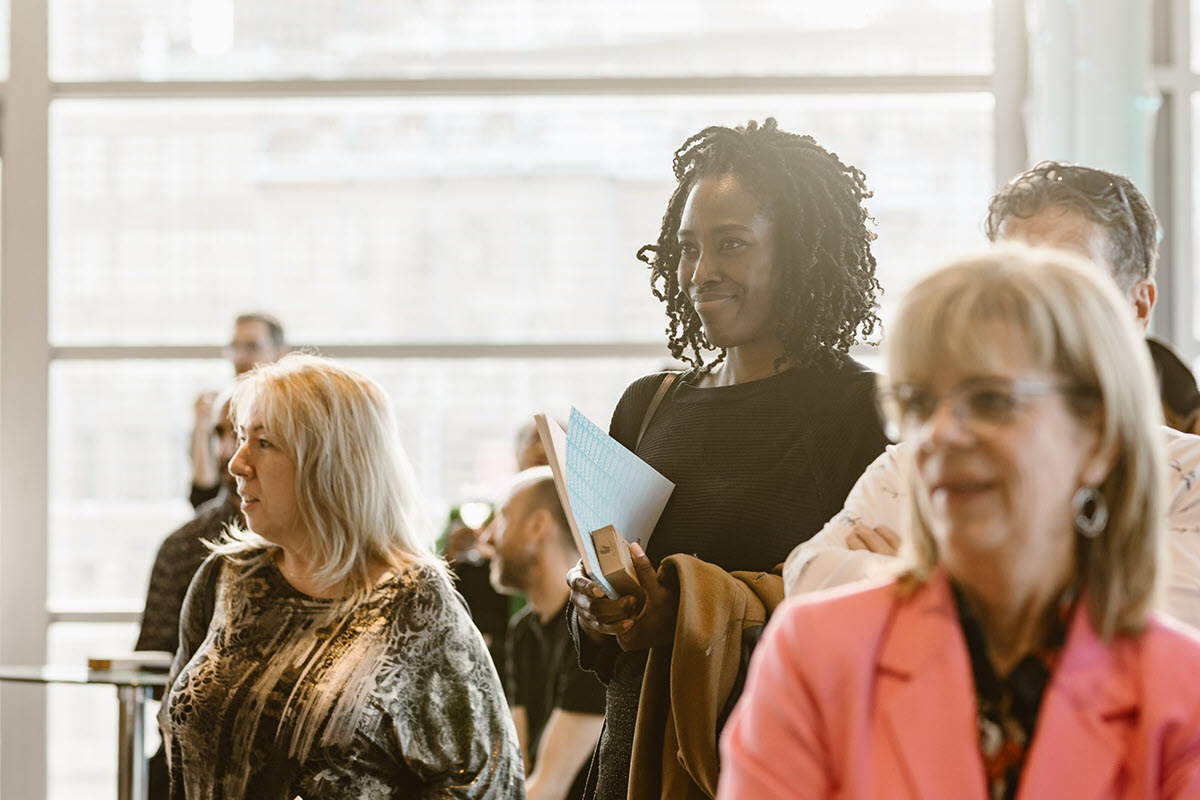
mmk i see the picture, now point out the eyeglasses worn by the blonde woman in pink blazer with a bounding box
[880,378,1096,439]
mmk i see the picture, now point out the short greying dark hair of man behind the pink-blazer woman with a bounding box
[984,161,1158,289]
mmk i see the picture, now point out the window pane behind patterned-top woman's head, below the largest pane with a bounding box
[49,357,667,606]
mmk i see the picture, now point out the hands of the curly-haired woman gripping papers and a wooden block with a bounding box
[566,545,679,650]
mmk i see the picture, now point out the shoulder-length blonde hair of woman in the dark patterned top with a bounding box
[215,354,445,602]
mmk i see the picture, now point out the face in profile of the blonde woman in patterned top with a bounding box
[229,403,307,548]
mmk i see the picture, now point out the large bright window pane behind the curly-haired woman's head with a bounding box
[50,95,994,344]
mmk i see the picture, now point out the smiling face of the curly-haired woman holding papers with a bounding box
[678,175,779,349]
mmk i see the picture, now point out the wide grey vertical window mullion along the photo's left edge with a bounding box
[0,0,50,798]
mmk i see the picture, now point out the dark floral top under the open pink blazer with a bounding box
[950,583,1076,800]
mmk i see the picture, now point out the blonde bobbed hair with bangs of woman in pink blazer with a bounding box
[886,245,1163,639]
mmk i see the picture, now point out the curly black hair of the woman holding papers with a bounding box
[637,118,882,371]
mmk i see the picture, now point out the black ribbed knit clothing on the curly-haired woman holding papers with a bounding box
[570,357,886,800]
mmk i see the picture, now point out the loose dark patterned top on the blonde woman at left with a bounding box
[160,551,524,800]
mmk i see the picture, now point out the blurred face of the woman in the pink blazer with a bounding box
[901,324,1109,592]
